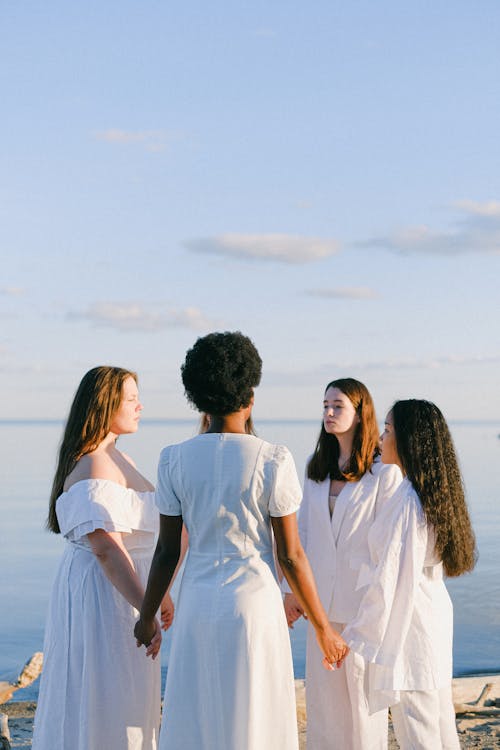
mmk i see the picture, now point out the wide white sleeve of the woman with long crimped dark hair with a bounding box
[342,492,427,667]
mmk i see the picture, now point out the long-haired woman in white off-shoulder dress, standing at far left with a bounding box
[33,367,173,750]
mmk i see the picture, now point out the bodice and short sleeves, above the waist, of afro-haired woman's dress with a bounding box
[157,433,298,558]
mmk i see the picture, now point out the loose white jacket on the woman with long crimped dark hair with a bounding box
[343,478,453,710]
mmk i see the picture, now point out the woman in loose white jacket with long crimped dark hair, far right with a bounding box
[343,399,476,750]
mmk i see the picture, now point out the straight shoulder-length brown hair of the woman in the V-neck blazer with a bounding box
[307,378,379,482]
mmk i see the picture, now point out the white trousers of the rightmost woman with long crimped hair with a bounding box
[391,685,460,750]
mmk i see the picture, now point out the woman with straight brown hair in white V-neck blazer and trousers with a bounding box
[283,378,402,750]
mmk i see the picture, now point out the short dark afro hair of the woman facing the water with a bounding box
[181,331,262,417]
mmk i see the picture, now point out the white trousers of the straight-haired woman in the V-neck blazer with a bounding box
[306,623,386,750]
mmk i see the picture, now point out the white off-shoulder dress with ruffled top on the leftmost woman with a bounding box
[33,479,160,750]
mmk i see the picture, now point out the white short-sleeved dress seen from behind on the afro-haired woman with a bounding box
[157,433,302,750]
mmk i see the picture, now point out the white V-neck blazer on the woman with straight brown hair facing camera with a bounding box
[283,460,402,624]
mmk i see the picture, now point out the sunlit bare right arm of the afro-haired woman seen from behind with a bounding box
[271,513,349,669]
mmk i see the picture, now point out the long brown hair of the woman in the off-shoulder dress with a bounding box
[47,366,137,534]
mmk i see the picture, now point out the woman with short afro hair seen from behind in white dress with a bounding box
[135,332,347,750]
